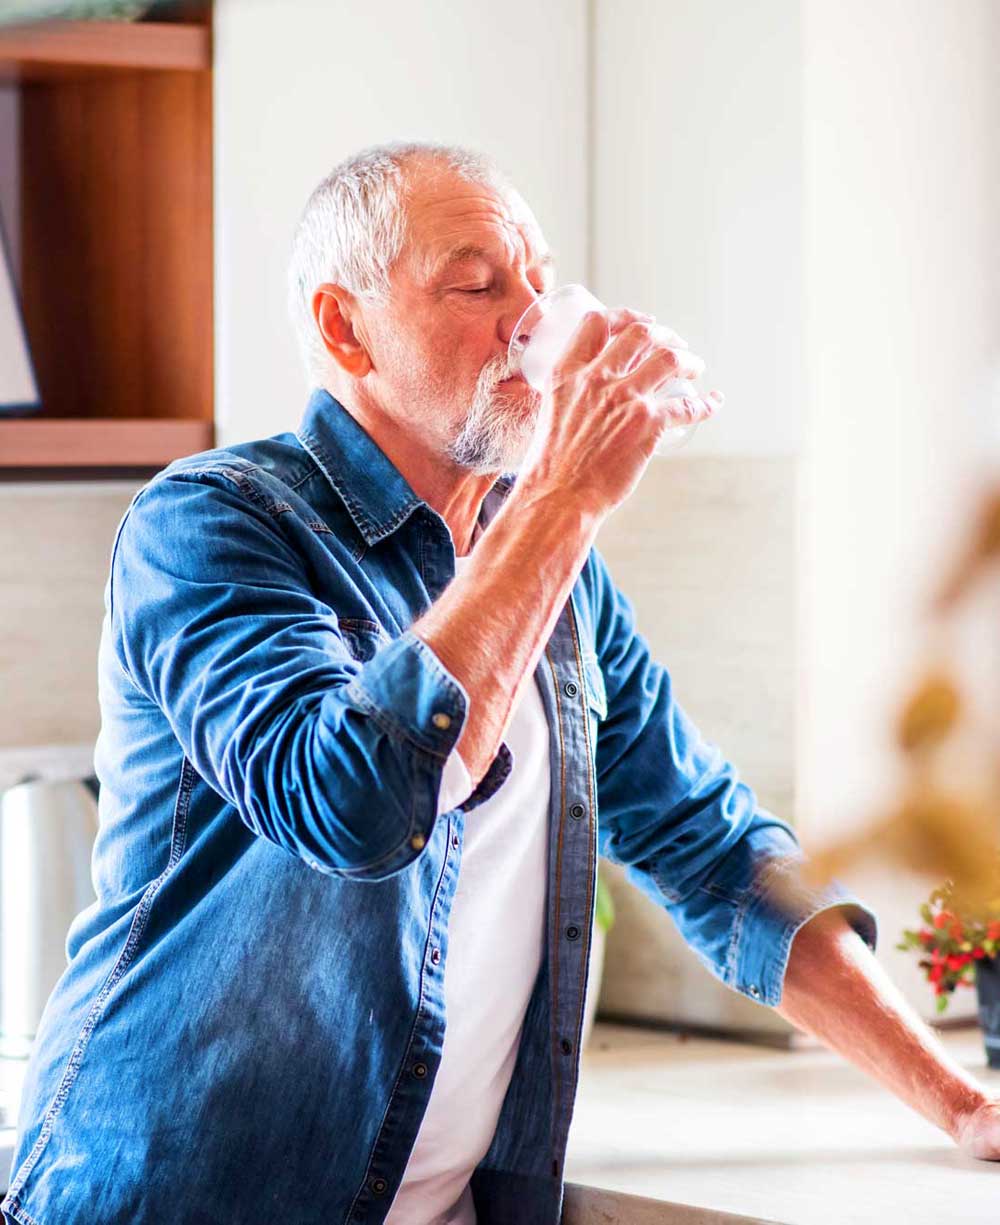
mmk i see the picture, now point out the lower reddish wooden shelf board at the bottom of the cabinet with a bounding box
[0,417,214,472]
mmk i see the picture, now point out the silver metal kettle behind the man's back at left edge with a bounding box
[0,777,98,1058]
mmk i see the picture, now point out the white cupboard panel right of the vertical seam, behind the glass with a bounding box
[593,0,804,456]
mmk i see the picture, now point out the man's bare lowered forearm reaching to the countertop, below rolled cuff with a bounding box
[777,911,989,1139]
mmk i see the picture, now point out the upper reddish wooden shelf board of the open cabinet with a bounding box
[0,21,212,81]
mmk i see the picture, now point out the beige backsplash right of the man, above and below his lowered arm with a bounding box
[598,454,795,1035]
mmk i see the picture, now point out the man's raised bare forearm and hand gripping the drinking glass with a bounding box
[413,310,721,778]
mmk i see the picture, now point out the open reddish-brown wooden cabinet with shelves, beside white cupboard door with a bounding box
[0,5,213,479]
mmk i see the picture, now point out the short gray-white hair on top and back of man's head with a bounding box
[288,141,510,383]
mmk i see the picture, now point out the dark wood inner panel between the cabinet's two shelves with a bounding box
[21,65,213,420]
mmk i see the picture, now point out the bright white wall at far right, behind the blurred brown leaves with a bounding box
[798,0,1000,1011]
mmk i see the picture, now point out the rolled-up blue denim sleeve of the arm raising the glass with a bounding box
[109,469,511,880]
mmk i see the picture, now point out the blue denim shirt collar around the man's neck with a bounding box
[297,387,516,548]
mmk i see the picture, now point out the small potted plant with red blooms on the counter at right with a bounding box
[896,878,1000,1067]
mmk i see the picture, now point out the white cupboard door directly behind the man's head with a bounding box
[214,0,587,445]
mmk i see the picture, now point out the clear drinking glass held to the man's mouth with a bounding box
[507,285,701,454]
